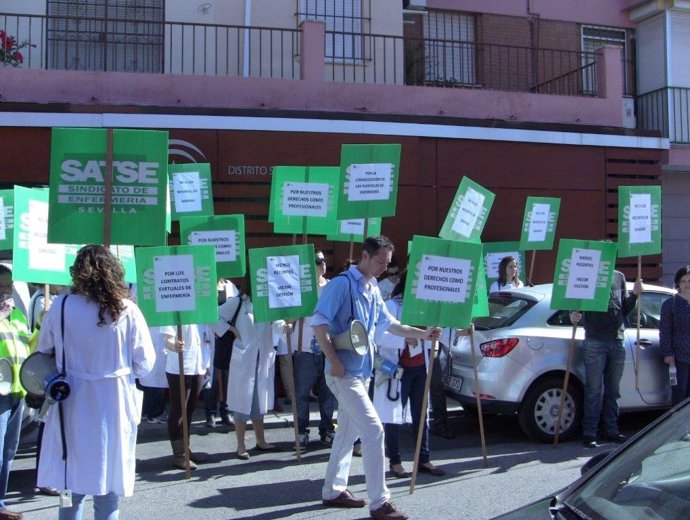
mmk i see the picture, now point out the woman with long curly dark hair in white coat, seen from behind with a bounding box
[38,245,155,520]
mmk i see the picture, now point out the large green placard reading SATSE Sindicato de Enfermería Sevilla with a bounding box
[48,128,168,245]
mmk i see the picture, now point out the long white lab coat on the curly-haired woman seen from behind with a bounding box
[38,295,156,496]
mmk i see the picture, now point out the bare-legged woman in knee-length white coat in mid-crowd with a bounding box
[214,275,279,460]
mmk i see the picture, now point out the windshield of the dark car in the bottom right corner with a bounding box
[564,404,690,520]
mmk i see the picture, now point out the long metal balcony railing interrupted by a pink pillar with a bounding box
[0,13,627,96]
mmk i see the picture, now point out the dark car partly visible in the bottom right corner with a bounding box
[494,399,690,520]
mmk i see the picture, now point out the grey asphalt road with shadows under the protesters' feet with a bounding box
[7,400,658,520]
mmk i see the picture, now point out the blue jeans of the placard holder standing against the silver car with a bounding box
[582,339,625,437]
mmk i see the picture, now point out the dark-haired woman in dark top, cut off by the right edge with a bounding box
[659,265,690,405]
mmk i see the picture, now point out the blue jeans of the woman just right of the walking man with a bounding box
[383,365,429,466]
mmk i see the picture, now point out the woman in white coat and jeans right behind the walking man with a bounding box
[374,272,444,478]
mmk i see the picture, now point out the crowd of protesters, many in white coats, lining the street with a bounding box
[0,241,664,520]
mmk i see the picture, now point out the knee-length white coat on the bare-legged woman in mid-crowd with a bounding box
[213,295,276,415]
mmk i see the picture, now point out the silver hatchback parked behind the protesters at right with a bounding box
[441,284,674,442]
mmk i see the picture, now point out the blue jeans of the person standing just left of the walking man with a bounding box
[293,352,335,434]
